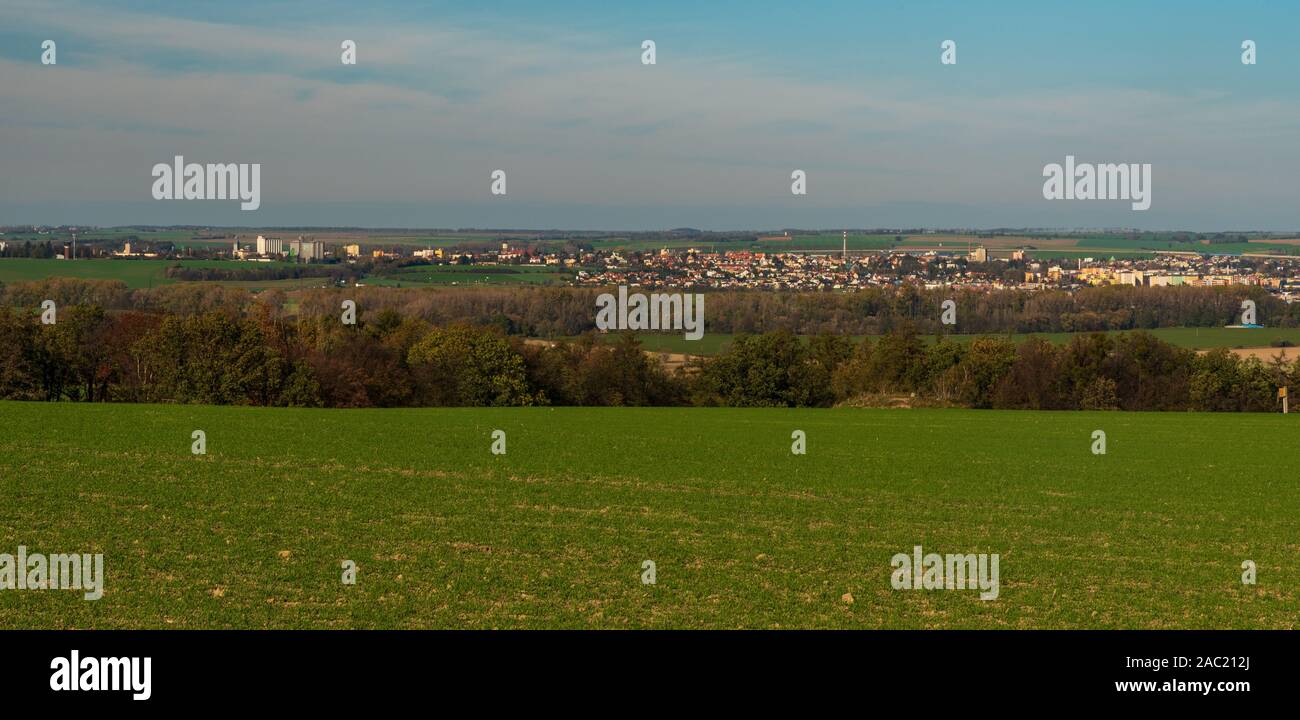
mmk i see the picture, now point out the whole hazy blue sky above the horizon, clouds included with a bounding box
[0,0,1300,230]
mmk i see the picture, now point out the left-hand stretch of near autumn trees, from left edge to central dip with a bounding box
[0,304,685,407]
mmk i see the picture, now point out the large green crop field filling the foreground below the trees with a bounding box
[0,403,1300,628]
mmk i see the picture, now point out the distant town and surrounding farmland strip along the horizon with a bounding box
[0,222,1300,303]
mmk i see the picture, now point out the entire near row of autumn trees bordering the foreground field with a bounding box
[0,304,1300,412]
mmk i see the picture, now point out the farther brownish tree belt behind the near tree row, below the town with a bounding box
[10,279,1300,338]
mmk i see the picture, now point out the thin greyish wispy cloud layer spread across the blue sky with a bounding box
[0,0,1300,226]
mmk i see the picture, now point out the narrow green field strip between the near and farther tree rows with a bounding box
[616,328,1300,355]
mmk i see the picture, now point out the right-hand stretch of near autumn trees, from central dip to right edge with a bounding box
[701,328,1300,412]
